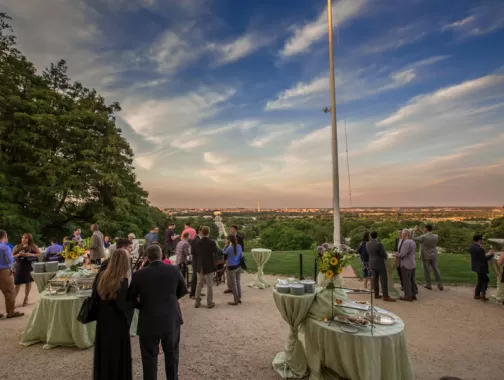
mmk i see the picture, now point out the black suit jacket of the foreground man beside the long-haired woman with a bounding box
[128,261,187,336]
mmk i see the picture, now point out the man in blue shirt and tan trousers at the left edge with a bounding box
[0,230,24,318]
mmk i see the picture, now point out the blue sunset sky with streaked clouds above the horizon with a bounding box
[0,0,504,208]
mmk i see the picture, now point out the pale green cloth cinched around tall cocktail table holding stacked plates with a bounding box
[272,291,315,379]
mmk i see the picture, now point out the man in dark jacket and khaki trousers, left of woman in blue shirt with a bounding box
[193,226,219,309]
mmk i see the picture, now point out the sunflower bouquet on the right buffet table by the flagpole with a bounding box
[315,243,352,286]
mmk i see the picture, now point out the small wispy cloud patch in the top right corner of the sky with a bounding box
[441,1,504,38]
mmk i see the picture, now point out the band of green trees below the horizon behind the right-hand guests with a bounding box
[226,216,504,253]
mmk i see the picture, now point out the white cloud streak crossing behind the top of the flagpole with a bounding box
[280,0,367,57]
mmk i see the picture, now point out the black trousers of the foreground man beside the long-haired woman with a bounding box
[139,328,180,380]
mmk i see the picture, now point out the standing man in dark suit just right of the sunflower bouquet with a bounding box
[366,231,395,302]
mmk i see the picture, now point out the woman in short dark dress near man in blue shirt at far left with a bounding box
[12,233,40,306]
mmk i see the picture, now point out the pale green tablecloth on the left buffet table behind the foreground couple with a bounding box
[20,292,138,349]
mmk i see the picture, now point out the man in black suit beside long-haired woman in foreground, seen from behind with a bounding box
[128,244,187,380]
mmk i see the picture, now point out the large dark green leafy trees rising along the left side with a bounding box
[0,13,167,244]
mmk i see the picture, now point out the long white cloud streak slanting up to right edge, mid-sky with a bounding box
[376,75,504,127]
